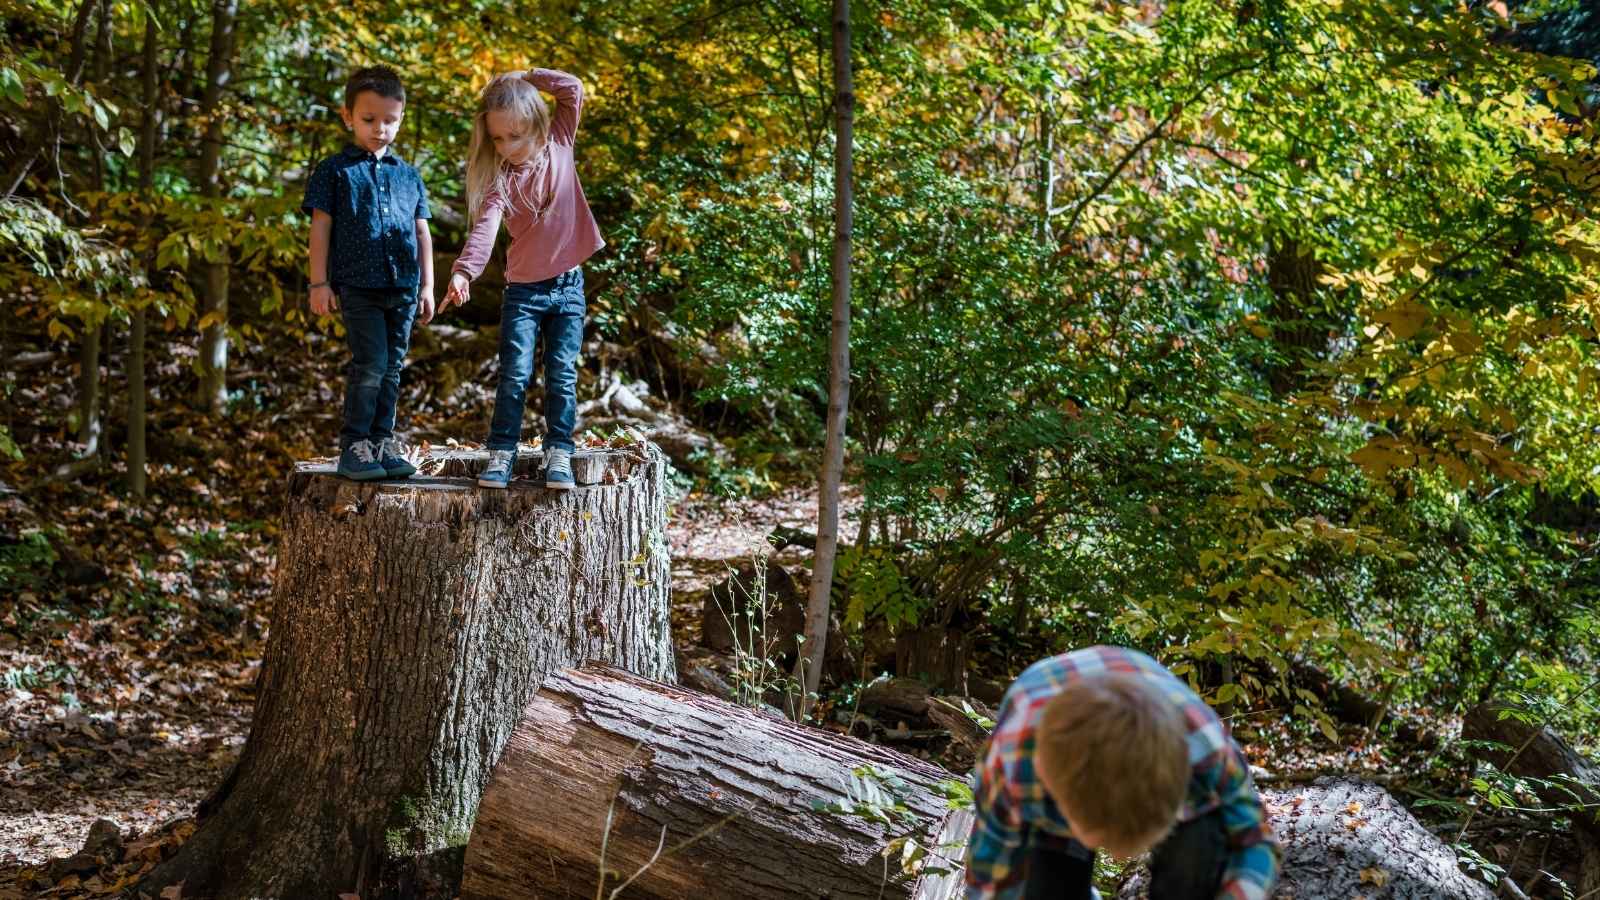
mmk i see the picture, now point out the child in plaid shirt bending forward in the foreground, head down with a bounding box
[966,647,1278,900]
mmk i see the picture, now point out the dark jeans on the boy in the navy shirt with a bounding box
[339,287,416,450]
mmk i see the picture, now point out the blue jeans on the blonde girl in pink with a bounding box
[488,269,584,450]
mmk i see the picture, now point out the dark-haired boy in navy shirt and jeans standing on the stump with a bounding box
[301,66,434,480]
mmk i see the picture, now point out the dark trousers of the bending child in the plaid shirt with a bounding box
[1022,812,1229,900]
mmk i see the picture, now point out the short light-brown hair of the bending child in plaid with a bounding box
[1035,673,1190,846]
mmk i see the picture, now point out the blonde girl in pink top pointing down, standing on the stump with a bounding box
[442,69,605,490]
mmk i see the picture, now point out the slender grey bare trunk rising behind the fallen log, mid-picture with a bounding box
[795,0,856,719]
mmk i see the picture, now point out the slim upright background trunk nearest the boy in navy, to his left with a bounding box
[195,0,238,413]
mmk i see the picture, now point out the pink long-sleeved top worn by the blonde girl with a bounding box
[450,69,605,283]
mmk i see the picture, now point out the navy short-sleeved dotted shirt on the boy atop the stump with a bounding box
[301,146,432,290]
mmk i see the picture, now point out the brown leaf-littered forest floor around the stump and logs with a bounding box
[0,323,1570,900]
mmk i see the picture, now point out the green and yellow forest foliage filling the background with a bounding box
[9,0,1600,743]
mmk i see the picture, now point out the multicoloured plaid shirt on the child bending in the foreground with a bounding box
[966,647,1278,900]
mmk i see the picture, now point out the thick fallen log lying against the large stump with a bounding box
[461,666,971,900]
